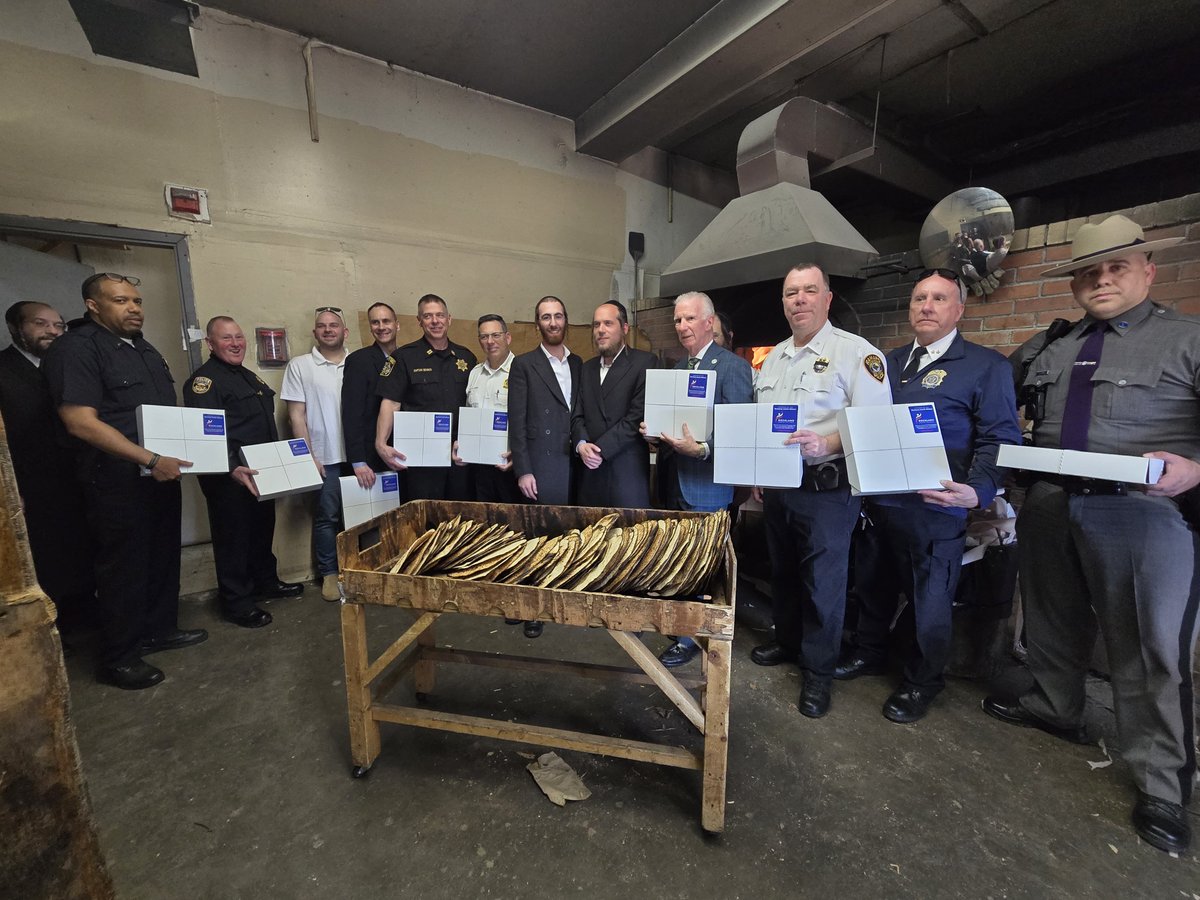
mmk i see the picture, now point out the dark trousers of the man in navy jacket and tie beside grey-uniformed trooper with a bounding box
[854,502,966,694]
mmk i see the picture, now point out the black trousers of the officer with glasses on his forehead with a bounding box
[83,455,182,666]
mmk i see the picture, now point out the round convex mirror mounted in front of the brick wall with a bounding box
[920,187,1013,294]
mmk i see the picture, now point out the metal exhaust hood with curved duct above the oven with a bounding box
[659,97,948,296]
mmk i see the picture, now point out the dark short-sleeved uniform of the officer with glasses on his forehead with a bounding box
[42,314,182,668]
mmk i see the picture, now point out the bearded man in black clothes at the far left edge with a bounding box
[0,300,96,634]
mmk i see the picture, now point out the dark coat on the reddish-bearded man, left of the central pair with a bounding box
[509,346,583,505]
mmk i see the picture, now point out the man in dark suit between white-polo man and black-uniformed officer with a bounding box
[342,302,396,488]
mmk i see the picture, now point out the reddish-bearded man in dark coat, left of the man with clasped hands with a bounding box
[506,296,583,637]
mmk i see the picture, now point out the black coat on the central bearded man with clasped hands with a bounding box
[571,347,656,509]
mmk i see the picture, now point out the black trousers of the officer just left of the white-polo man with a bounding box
[198,475,278,616]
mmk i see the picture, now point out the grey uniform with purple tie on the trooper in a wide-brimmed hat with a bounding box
[1016,299,1200,804]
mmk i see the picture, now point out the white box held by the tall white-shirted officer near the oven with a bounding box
[713,403,804,487]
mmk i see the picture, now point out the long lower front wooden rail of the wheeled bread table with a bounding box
[372,704,702,769]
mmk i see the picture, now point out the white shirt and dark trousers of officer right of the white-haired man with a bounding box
[755,322,892,683]
